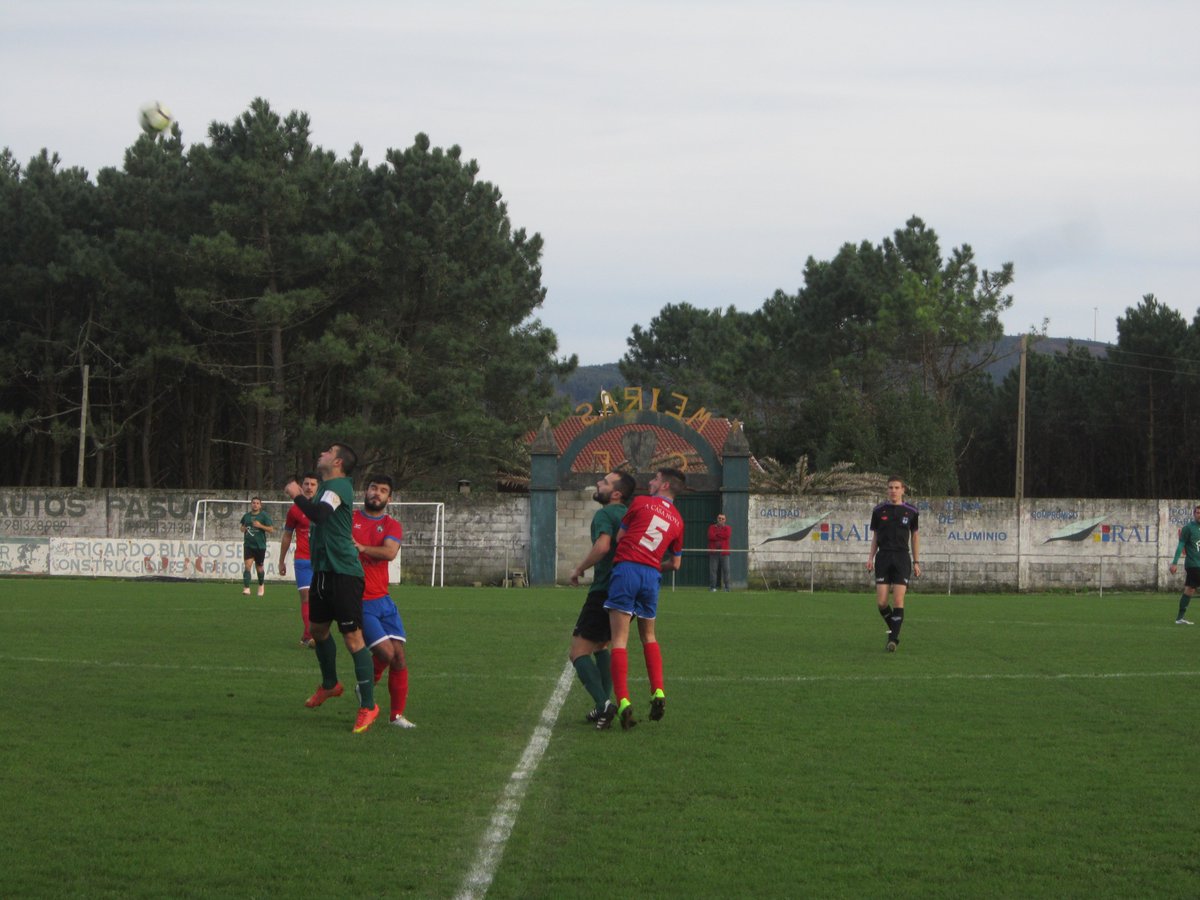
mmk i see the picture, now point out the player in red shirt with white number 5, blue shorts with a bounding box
[598,469,684,731]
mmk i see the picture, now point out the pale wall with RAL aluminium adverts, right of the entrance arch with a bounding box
[750,497,1193,593]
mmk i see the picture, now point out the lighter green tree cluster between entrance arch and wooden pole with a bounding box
[622,217,1013,493]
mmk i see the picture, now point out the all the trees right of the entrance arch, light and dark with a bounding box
[620,217,1200,498]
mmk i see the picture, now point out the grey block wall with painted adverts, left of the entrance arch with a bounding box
[0,488,529,584]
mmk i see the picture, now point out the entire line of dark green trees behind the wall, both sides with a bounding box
[0,100,1200,498]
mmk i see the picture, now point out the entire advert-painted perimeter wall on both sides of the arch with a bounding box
[0,488,1193,593]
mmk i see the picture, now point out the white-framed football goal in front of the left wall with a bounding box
[192,497,446,587]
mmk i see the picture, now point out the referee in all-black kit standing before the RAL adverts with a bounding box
[866,475,920,653]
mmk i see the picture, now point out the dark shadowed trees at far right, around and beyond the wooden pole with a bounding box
[961,314,1200,498]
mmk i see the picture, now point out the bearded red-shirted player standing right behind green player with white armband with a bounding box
[354,475,416,728]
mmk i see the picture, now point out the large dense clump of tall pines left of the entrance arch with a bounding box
[0,100,576,488]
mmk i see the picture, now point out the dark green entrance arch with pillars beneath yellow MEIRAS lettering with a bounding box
[529,409,750,588]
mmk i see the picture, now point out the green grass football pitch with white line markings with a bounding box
[0,580,1200,898]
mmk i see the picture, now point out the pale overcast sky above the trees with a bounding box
[0,0,1200,365]
